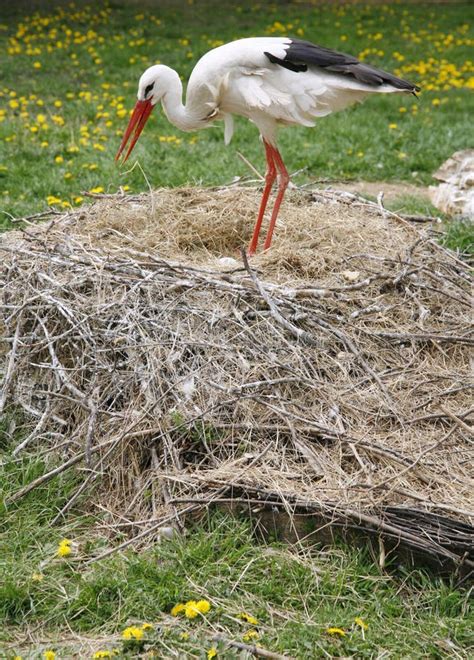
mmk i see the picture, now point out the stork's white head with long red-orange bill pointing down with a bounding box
[115,64,170,162]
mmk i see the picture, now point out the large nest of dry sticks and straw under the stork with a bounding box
[0,187,474,571]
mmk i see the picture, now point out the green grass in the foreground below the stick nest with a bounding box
[0,453,473,658]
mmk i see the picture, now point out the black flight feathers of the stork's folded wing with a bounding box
[265,39,420,93]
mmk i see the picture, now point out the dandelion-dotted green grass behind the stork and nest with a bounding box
[0,0,474,228]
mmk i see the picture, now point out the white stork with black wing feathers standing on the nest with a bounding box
[116,37,419,254]
